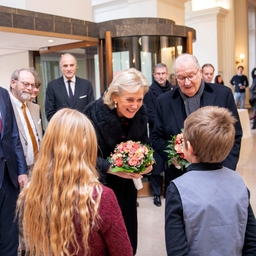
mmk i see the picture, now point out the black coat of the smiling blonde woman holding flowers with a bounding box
[85,98,149,254]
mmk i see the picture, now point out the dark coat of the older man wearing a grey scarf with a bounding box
[152,83,242,176]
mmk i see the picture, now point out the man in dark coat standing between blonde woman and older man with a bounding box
[143,63,172,206]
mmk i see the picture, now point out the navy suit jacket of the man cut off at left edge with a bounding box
[0,87,27,187]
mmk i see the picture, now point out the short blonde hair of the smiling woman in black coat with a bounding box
[103,68,149,109]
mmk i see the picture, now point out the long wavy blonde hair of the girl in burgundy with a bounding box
[17,109,102,256]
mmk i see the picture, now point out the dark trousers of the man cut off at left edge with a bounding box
[0,167,19,256]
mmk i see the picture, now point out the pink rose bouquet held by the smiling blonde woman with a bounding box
[107,140,154,189]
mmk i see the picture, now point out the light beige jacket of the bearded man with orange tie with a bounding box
[11,100,43,166]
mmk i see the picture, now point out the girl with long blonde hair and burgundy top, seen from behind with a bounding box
[17,109,132,256]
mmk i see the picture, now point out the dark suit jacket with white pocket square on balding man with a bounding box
[45,76,94,121]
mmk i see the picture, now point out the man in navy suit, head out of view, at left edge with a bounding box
[0,87,28,256]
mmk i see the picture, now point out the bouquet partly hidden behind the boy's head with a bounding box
[165,130,189,171]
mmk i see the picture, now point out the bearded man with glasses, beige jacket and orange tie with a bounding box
[10,68,43,256]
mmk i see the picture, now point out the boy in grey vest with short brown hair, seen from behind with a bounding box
[165,106,256,256]
